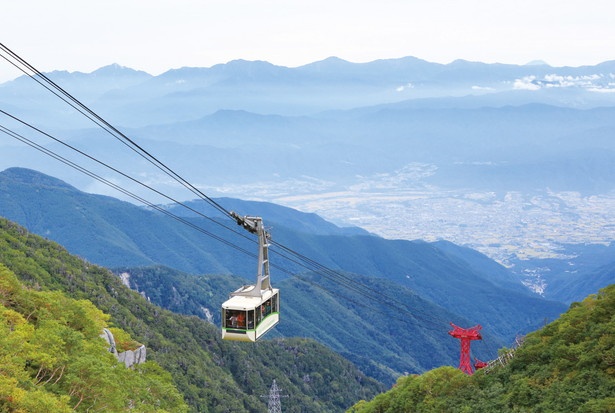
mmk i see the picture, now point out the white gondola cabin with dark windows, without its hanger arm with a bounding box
[222,285,280,341]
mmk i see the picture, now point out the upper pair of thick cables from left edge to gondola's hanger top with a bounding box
[0,43,232,218]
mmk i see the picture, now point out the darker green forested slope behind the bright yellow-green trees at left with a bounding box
[0,219,383,413]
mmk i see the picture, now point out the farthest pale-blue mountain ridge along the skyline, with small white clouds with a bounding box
[0,57,615,127]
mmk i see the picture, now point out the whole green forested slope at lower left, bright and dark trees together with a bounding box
[0,218,385,413]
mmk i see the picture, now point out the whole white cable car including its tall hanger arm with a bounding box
[222,212,280,341]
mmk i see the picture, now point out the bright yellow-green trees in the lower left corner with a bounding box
[0,264,188,413]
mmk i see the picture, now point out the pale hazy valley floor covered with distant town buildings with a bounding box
[192,164,615,267]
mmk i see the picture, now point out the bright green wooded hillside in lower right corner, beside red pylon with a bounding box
[348,284,615,413]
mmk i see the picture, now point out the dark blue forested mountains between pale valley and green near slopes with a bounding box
[0,168,565,383]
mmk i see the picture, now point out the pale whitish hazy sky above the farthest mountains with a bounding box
[0,0,615,81]
